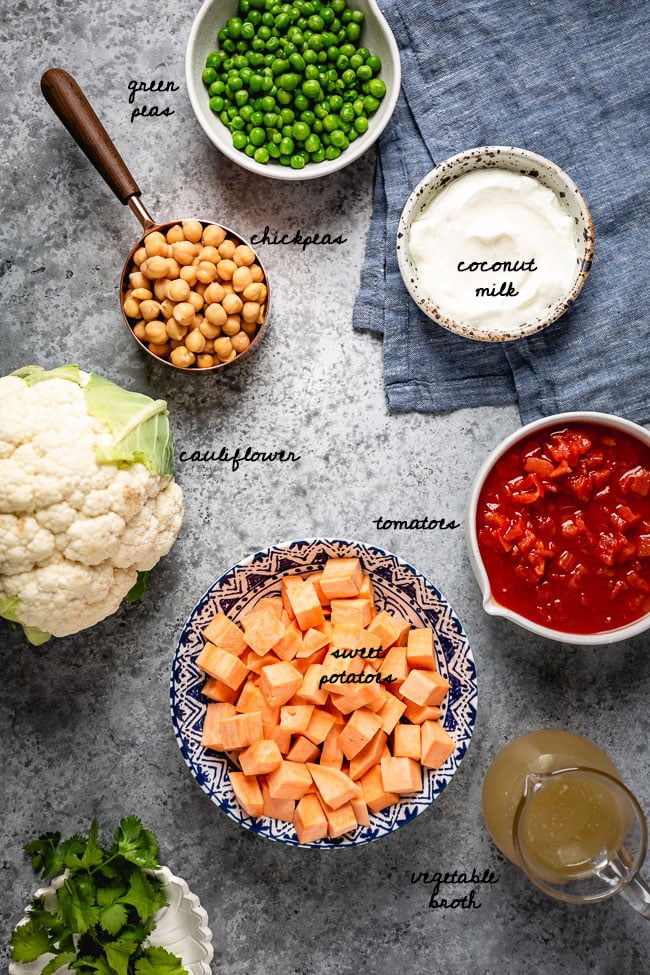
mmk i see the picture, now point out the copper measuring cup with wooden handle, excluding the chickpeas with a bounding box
[41,68,271,373]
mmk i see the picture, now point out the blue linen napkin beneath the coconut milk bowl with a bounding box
[354,0,650,423]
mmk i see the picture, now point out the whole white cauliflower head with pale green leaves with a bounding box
[0,366,183,644]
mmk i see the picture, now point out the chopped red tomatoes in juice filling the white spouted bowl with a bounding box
[476,423,650,633]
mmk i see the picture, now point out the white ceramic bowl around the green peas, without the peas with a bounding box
[185,0,401,180]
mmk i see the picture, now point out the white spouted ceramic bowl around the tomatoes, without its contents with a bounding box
[465,411,650,646]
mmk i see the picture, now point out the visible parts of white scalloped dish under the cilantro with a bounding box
[9,867,214,975]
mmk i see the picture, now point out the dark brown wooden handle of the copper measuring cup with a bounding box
[41,68,140,203]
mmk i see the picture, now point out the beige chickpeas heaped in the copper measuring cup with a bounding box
[122,220,268,369]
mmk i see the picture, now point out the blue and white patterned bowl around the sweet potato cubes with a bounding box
[170,538,477,848]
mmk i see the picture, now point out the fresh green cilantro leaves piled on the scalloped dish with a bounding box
[11,816,187,975]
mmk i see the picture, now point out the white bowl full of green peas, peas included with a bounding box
[185,0,401,180]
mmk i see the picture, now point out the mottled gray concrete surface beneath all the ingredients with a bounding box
[0,0,650,975]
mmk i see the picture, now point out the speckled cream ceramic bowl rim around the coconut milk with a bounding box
[397,146,594,342]
